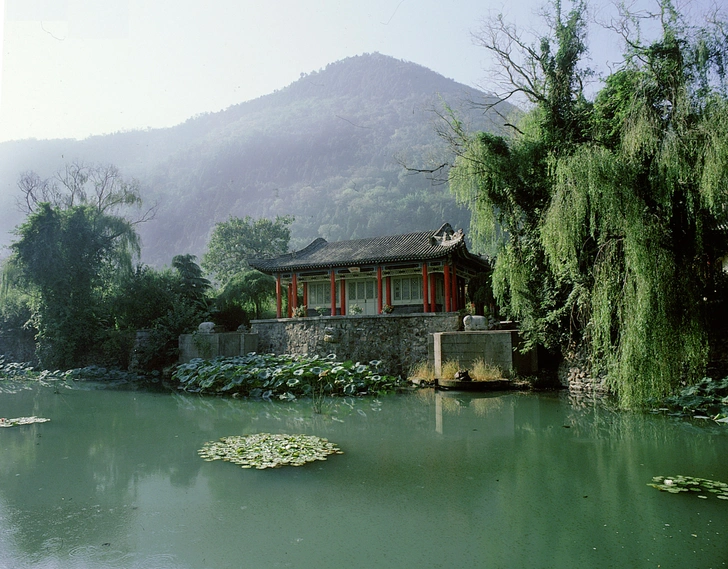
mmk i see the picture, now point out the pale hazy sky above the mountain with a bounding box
[0,0,708,141]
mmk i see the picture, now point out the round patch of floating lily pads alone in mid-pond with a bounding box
[198,433,343,470]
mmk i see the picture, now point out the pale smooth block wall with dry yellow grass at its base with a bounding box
[431,330,538,377]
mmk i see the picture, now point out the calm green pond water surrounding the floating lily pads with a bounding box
[0,381,728,569]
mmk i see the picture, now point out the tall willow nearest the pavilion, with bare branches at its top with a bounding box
[449,2,591,349]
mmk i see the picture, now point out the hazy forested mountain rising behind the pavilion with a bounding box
[0,53,517,266]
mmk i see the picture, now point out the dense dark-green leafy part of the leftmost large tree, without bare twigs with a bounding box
[12,203,138,368]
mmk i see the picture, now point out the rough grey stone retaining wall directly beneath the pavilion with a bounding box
[251,313,459,375]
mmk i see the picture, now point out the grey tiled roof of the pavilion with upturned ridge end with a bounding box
[248,223,484,273]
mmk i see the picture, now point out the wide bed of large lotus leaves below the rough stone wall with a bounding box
[172,352,406,401]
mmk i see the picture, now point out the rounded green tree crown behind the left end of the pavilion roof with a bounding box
[202,216,293,286]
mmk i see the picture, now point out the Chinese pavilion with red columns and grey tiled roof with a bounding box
[248,223,489,318]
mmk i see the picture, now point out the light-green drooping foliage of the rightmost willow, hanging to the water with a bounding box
[542,6,728,404]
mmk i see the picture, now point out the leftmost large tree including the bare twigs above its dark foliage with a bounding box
[9,165,152,368]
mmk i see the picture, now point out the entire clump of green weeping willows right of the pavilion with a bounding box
[451,2,728,406]
